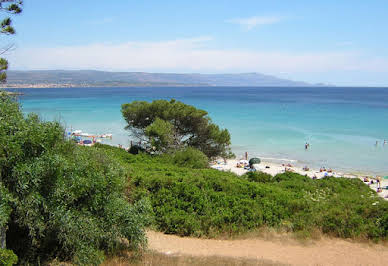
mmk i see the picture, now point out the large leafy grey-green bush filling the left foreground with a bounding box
[0,96,150,264]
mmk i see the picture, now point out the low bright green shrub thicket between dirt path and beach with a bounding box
[98,145,388,240]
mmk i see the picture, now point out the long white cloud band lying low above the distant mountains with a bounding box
[8,37,388,75]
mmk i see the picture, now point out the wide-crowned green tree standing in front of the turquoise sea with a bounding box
[121,99,232,158]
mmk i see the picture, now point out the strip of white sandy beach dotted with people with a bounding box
[210,159,388,200]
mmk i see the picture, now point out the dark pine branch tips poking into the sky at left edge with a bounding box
[0,0,23,82]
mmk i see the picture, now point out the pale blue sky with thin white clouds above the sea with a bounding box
[1,0,388,87]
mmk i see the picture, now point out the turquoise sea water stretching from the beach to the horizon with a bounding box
[10,87,388,175]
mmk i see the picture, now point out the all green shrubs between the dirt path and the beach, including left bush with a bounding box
[0,94,388,265]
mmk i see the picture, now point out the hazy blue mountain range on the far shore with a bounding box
[6,70,322,87]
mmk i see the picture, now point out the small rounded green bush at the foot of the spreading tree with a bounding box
[171,147,209,169]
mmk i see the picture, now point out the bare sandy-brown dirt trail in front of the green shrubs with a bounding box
[147,231,388,265]
